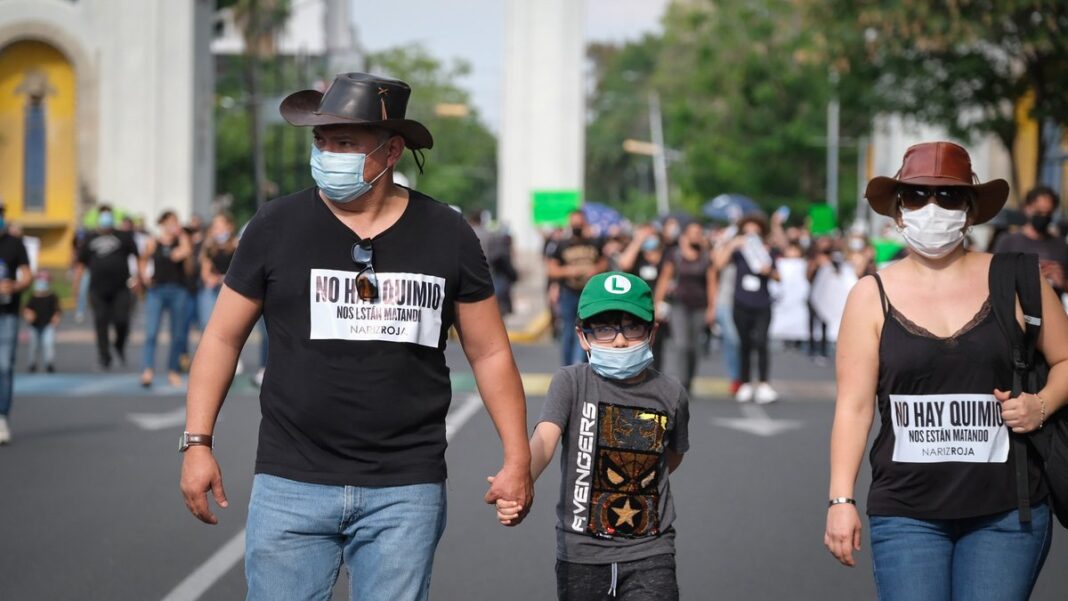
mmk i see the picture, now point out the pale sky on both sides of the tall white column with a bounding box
[352,0,670,130]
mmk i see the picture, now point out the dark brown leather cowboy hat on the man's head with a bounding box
[279,73,434,151]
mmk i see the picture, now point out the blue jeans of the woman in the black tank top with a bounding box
[870,503,1053,601]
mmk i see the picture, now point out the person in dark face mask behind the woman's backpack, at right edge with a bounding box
[993,186,1068,296]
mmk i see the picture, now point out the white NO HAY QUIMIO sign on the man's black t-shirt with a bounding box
[308,269,445,348]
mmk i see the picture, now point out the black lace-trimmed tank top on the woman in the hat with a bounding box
[867,274,1048,520]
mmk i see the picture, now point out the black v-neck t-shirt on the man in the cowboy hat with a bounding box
[225,188,493,486]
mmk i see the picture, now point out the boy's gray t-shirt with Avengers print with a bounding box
[538,364,690,564]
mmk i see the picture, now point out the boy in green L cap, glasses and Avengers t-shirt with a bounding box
[491,272,690,601]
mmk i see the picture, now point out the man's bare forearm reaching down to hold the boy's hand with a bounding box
[471,348,531,465]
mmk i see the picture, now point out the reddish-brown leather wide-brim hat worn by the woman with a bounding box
[864,142,1008,224]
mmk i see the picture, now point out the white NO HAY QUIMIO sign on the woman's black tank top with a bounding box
[890,394,1009,463]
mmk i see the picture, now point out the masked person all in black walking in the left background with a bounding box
[74,205,138,370]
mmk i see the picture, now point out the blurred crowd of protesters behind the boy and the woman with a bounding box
[544,187,1068,404]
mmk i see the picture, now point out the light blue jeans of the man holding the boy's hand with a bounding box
[245,474,445,601]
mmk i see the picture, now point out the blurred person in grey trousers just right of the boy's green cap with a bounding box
[654,221,716,392]
